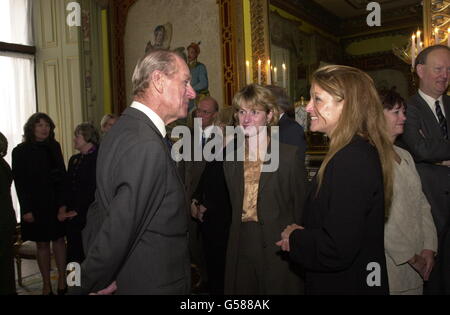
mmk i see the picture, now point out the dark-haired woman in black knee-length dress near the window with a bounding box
[12,113,66,294]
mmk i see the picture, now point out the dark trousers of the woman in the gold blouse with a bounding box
[235,222,266,295]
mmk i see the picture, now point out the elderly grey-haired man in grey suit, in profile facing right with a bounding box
[76,50,195,294]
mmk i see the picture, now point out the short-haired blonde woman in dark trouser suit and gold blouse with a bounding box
[224,84,306,295]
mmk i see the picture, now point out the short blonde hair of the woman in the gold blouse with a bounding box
[232,84,280,126]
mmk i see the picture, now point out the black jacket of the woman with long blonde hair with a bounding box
[289,137,389,294]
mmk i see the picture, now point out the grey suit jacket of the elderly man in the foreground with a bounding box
[81,108,190,294]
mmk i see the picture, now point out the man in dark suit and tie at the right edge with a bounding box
[399,45,450,294]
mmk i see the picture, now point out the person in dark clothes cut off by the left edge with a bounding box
[0,132,17,295]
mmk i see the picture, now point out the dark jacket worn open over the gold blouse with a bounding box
[224,143,306,294]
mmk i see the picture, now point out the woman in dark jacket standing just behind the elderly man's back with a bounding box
[58,123,99,263]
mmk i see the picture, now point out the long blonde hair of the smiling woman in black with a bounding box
[312,65,394,218]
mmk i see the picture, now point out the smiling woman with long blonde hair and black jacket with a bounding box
[277,66,394,294]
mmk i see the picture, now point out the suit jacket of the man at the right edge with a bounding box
[397,93,450,236]
